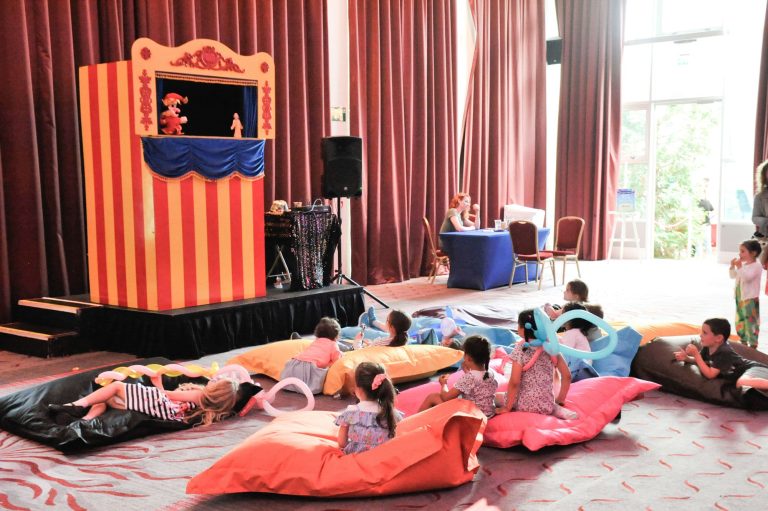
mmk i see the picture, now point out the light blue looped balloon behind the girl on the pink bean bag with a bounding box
[525,309,619,360]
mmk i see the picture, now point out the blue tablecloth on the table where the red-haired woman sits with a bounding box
[440,228,549,290]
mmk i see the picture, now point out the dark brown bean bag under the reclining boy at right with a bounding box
[632,335,768,410]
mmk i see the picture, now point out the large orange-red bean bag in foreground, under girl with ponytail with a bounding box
[187,400,486,497]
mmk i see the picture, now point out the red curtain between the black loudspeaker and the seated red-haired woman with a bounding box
[349,0,458,284]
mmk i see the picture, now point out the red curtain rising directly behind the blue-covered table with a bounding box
[455,0,546,226]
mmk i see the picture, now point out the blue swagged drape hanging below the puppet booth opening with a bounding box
[141,137,264,179]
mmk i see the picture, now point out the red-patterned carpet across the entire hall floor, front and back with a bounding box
[0,261,768,511]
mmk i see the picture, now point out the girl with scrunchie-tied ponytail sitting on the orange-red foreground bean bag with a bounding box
[336,362,403,454]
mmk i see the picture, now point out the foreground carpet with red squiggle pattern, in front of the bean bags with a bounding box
[0,376,768,511]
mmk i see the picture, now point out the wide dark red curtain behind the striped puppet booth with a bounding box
[0,0,330,322]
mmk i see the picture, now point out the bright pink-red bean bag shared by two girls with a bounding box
[396,376,659,451]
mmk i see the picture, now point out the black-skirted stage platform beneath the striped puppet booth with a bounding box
[76,284,365,360]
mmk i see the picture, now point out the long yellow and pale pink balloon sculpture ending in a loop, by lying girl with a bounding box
[95,362,315,417]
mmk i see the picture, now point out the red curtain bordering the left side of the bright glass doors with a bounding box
[555,0,624,259]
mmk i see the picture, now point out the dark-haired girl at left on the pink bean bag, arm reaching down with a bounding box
[419,335,499,418]
